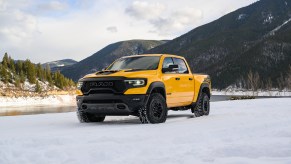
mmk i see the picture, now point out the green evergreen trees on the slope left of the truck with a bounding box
[0,53,75,92]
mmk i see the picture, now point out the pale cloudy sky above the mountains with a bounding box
[0,0,257,63]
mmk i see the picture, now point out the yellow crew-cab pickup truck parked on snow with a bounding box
[76,54,211,123]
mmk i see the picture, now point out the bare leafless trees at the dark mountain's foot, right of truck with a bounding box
[235,66,291,91]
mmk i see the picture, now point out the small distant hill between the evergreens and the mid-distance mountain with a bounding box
[41,59,77,72]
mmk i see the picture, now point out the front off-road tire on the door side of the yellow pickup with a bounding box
[139,93,168,124]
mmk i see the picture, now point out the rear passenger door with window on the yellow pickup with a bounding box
[173,57,194,106]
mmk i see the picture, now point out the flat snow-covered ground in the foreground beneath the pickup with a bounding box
[0,98,291,164]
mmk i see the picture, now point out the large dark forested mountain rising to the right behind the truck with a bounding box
[147,0,291,88]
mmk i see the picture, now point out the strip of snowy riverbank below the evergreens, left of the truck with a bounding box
[0,95,76,107]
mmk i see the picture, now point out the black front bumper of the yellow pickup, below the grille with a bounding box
[76,94,148,116]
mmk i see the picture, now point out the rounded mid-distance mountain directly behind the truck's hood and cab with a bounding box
[61,40,166,81]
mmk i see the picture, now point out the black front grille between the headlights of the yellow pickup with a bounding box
[81,80,126,94]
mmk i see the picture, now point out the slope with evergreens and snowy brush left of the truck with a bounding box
[0,53,75,97]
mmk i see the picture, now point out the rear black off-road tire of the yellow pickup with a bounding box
[193,92,210,117]
